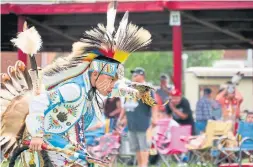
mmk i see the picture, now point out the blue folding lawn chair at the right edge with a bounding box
[215,122,253,166]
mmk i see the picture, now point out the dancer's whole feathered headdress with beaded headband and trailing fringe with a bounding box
[44,2,151,90]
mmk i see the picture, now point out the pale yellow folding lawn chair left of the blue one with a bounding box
[186,120,232,164]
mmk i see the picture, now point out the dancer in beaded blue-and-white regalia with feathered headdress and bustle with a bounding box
[0,2,155,167]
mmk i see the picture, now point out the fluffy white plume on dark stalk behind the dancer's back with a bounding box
[11,27,42,56]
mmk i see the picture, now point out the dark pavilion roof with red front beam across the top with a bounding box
[1,1,253,51]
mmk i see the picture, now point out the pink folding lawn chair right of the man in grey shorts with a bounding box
[153,120,191,167]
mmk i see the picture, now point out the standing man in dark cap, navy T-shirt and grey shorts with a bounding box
[119,68,157,167]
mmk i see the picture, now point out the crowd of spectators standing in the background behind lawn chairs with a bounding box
[102,67,253,167]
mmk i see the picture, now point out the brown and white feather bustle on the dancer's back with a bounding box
[0,61,31,154]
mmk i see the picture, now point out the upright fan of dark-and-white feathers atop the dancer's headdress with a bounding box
[75,2,151,63]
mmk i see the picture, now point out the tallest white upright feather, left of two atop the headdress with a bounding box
[106,1,117,35]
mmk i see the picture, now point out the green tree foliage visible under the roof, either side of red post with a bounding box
[125,50,223,84]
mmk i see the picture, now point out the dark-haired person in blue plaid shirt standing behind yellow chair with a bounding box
[195,88,212,135]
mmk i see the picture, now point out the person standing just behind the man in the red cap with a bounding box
[156,74,172,111]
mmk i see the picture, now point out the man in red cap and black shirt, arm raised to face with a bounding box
[166,89,195,135]
